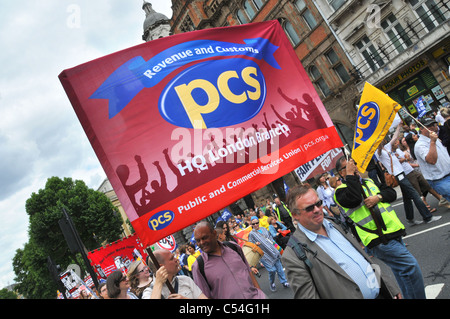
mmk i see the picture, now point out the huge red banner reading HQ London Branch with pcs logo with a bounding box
[59,21,342,250]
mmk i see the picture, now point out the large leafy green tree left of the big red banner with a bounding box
[13,177,122,298]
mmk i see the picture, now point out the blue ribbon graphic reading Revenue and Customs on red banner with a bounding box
[89,38,281,118]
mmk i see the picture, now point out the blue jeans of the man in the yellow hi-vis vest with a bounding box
[366,239,426,299]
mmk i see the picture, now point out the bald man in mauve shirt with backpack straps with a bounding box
[192,222,266,299]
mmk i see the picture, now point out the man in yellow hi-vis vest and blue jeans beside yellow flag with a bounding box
[334,157,426,299]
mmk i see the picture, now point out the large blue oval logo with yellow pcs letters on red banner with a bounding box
[159,58,267,129]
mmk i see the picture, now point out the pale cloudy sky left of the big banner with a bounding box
[0,0,172,289]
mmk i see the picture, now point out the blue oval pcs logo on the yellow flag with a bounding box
[354,102,380,149]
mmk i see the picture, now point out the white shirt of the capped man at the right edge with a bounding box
[414,135,450,180]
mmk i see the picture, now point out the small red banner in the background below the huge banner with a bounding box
[88,234,147,279]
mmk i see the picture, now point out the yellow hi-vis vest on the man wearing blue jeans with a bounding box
[334,179,405,248]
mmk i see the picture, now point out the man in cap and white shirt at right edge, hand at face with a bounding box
[414,118,450,201]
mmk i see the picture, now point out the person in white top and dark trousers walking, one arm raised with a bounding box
[376,124,442,225]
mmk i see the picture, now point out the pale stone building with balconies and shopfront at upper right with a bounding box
[315,0,450,122]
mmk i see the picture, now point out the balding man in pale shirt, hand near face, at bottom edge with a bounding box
[142,249,207,299]
